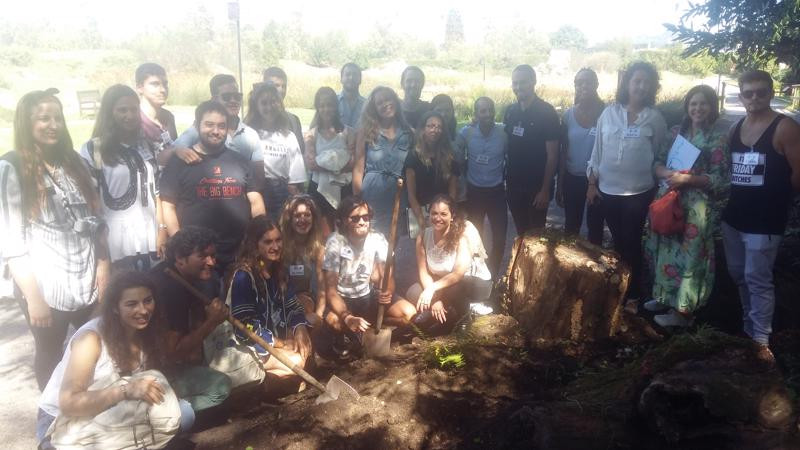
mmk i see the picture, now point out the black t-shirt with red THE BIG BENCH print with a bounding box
[160,148,257,266]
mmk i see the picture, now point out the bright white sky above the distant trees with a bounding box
[3,0,688,45]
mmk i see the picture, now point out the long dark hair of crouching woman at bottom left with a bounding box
[100,271,164,371]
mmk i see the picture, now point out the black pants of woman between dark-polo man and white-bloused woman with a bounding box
[563,173,603,245]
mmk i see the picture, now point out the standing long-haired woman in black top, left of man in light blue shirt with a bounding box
[405,111,459,234]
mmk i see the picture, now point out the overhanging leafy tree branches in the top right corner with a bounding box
[664,0,800,80]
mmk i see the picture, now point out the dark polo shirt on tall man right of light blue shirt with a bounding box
[503,97,561,192]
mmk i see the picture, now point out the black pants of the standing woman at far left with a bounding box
[17,292,94,391]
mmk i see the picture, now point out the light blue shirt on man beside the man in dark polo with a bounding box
[456,124,508,187]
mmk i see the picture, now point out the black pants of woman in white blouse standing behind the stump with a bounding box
[601,188,656,298]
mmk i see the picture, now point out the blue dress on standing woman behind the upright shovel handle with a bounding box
[361,129,414,238]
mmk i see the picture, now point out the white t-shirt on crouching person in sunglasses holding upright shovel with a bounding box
[322,231,389,298]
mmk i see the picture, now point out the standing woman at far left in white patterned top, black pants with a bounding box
[0,89,110,389]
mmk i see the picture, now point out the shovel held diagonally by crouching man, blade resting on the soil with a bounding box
[164,267,360,405]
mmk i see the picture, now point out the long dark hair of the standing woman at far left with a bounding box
[14,88,99,220]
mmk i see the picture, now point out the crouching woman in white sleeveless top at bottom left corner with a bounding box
[36,272,194,449]
